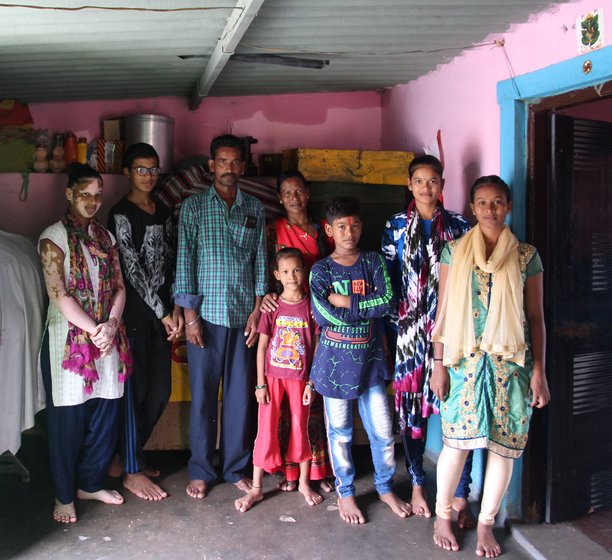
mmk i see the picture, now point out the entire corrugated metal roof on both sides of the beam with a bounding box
[0,0,572,102]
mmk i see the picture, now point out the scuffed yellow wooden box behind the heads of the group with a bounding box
[283,148,414,186]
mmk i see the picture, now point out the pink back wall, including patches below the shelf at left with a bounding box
[0,92,382,238]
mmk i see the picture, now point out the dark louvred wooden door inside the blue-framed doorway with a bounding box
[544,111,612,522]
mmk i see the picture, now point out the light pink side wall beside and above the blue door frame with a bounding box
[382,0,612,215]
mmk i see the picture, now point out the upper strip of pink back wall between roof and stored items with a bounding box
[30,91,382,163]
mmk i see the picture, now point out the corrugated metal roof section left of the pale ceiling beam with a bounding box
[0,0,234,102]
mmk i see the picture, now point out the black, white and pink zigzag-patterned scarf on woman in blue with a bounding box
[393,201,462,439]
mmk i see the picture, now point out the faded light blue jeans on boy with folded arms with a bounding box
[323,382,395,498]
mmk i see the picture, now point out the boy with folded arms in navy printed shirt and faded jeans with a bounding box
[310,197,411,523]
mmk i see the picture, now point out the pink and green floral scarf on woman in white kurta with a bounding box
[62,209,132,395]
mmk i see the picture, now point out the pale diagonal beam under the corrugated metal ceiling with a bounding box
[189,0,264,111]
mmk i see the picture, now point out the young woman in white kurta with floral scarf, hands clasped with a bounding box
[39,164,131,523]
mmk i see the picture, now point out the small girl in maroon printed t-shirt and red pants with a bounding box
[235,248,323,512]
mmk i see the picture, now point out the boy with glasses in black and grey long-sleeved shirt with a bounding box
[108,142,183,501]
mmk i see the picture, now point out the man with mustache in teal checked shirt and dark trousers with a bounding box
[175,135,268,499]
